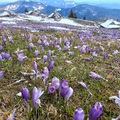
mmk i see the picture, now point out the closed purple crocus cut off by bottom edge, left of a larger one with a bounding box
[74,108,85,120]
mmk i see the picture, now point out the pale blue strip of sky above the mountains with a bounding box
[0,0,120,3]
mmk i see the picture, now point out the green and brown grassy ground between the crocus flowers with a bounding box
[0,25,120,120]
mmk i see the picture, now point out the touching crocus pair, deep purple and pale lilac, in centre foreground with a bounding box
[60,79,73,102]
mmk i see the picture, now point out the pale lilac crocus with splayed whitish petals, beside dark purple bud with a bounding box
[32,87,44,107]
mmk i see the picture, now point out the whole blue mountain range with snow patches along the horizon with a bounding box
[0,0,120,21]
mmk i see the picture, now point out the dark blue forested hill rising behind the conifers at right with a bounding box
[64,4,120,21]
